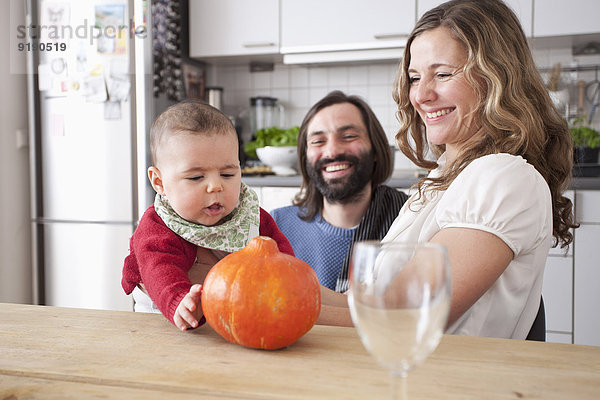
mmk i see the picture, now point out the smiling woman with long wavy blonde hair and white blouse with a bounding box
[383,0,574,339]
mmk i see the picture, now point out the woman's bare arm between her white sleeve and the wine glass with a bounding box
[431,228,513,327]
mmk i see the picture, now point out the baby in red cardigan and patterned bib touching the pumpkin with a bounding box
[121,101,293,330]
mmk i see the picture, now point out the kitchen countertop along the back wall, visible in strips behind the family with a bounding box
[242,175,600,190]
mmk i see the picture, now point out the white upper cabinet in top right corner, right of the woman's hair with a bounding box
[533,0,600,37]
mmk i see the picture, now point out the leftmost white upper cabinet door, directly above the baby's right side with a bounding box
[189,0,279,57]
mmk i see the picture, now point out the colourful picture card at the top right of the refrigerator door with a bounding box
[94,4,127,54]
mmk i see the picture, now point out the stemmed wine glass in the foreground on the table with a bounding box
[348,241,450,399]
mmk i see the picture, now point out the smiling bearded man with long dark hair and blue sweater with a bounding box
[271,91,408,293]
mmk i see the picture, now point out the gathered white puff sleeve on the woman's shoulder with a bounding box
[435,154,552,256]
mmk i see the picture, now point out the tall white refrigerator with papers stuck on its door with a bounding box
[26,0,154,310]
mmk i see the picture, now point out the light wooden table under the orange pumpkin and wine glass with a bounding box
[0,304,600,400]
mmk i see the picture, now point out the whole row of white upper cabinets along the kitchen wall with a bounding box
[189,0,600,64]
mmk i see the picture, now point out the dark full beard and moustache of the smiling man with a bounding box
[306,151,374,204]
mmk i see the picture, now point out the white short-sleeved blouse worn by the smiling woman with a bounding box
[383,154,552,339]
